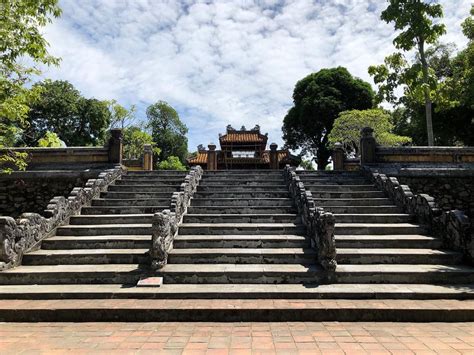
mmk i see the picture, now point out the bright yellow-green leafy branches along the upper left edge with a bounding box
[0,0,61,172]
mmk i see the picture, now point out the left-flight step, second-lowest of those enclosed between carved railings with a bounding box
[41,235,151,250]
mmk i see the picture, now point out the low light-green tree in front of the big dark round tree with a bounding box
[329,109,411,155]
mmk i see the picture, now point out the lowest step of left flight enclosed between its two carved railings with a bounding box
[22,248,149,265]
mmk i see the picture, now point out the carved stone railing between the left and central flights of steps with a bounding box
[150,166,203,270]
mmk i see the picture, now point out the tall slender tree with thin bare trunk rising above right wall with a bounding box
[369,0,446,145]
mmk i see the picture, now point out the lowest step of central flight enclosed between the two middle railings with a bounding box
[168,248,317,264]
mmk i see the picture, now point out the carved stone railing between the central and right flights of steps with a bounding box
[284,165,337,271]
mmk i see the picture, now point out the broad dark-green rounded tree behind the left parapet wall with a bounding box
[23,80,111,146]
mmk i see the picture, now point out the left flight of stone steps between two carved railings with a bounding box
[0,171,186,286]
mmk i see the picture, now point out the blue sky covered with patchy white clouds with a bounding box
[39,0,471,150]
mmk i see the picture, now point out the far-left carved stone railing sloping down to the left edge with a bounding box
[0,166,123,269]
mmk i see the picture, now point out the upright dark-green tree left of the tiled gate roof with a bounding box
[146,101,188,164]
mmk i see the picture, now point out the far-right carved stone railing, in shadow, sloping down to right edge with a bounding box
[362,167,474,264]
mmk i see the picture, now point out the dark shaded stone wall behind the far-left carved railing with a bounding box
[0,170,100,218]
